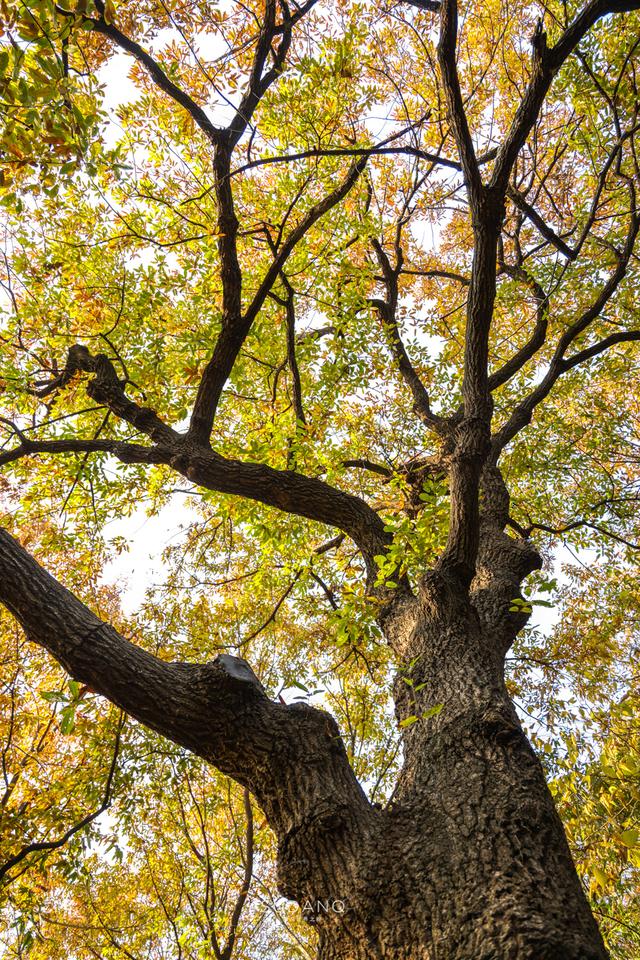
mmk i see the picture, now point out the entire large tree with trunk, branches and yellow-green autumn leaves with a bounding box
[0,0,640,960]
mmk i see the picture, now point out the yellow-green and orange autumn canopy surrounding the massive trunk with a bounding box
[0,0,640,960]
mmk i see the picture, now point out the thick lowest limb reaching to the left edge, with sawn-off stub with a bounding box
[0,530,368,860]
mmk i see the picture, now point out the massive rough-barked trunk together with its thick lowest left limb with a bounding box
[0,524,606,960]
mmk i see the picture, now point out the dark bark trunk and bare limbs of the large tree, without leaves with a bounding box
[0,0,640,960]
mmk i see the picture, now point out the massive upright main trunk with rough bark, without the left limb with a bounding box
[280,590,606,960]
